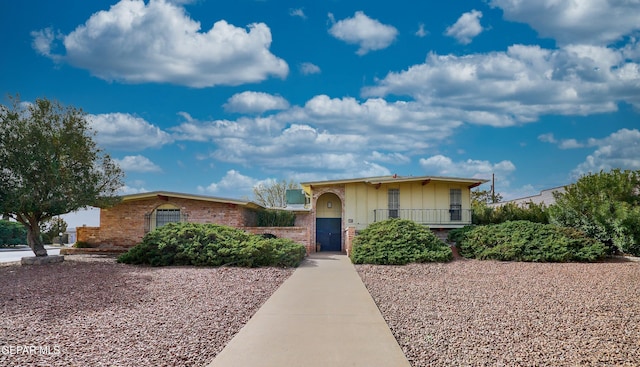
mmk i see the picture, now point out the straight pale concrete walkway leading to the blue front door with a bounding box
[208,253,410,367]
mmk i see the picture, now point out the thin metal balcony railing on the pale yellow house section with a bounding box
[373,209,473,225]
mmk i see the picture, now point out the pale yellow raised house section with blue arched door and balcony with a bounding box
[301,175,488,253]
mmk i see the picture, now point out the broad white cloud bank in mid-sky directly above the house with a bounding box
[180,95,461,177]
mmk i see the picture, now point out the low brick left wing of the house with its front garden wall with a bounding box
[68,191,311,253]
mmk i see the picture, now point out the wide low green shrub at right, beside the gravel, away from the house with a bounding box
[457,221,607,262]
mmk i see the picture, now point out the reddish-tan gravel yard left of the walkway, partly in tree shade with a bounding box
[0,255,293,367]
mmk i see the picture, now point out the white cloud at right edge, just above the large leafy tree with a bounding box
[572,129,640,178]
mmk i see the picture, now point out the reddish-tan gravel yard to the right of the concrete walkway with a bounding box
[357,260,640,367]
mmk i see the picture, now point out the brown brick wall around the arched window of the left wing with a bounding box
[90,197,256,247]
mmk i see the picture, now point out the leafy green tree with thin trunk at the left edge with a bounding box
[0,97,123,256]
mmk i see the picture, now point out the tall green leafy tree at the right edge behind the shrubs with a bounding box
[549,169,640,255]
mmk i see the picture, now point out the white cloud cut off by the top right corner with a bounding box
[490,0,640,45]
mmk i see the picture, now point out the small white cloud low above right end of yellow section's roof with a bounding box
[420,154,516,179]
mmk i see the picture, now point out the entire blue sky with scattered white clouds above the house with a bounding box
[0,0,640,208]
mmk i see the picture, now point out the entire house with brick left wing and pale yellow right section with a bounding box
[69,175,488,253]
